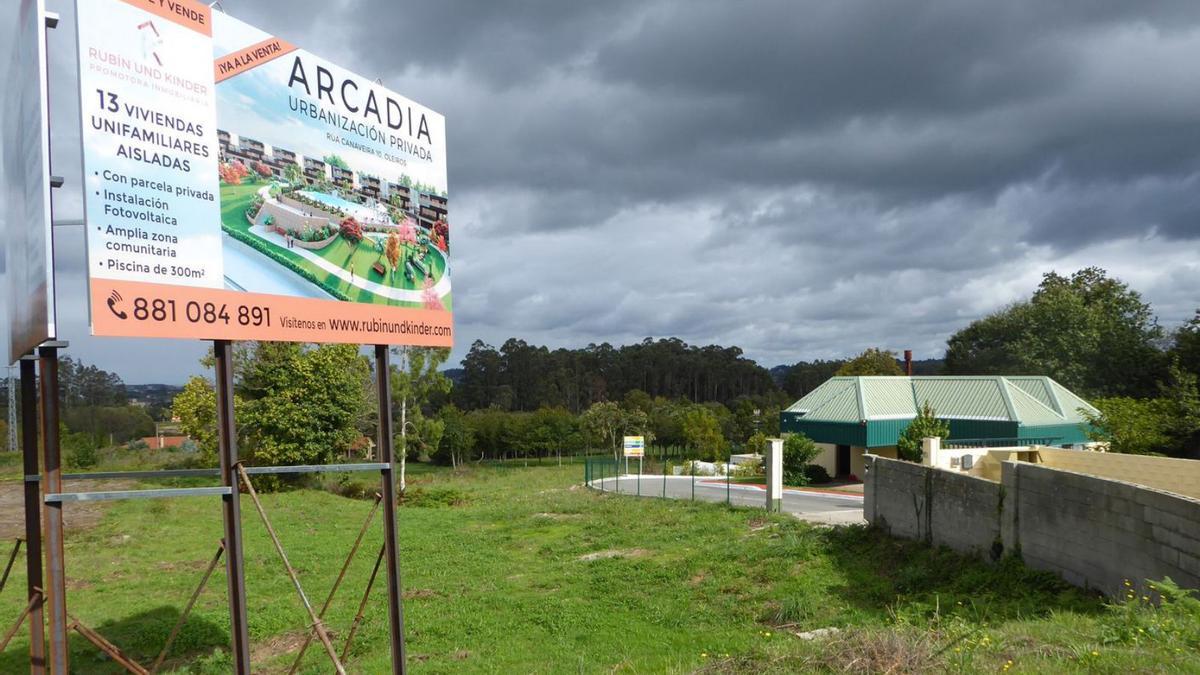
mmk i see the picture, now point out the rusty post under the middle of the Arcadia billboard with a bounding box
[212,340,250,675]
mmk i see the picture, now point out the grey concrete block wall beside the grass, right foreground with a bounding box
[863,455,1200,595]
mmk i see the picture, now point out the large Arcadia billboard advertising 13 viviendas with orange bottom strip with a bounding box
[77,0,452,346]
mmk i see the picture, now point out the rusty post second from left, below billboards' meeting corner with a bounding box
[37,342,71,675]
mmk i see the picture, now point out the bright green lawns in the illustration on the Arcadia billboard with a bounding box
[221,180,451,307]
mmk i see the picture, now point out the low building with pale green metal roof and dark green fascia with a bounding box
[780,376,1099,478]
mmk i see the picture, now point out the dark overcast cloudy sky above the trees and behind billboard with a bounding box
[0,0,1200,383]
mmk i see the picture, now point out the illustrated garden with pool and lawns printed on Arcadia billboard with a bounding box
[221,163,451,310]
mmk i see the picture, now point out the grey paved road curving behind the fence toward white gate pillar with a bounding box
[592,476,863,525]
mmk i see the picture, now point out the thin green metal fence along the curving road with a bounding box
[583,455,767,507]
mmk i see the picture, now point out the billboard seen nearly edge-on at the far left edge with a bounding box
[0,0,55,363]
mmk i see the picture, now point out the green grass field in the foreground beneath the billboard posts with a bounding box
[0,464,1200,673]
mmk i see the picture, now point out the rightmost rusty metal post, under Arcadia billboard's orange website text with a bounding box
[376,345,407,675]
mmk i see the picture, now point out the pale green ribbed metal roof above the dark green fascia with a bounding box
[786,376,1096,426]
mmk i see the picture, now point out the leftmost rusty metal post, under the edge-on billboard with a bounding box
[19,356,46,675]
